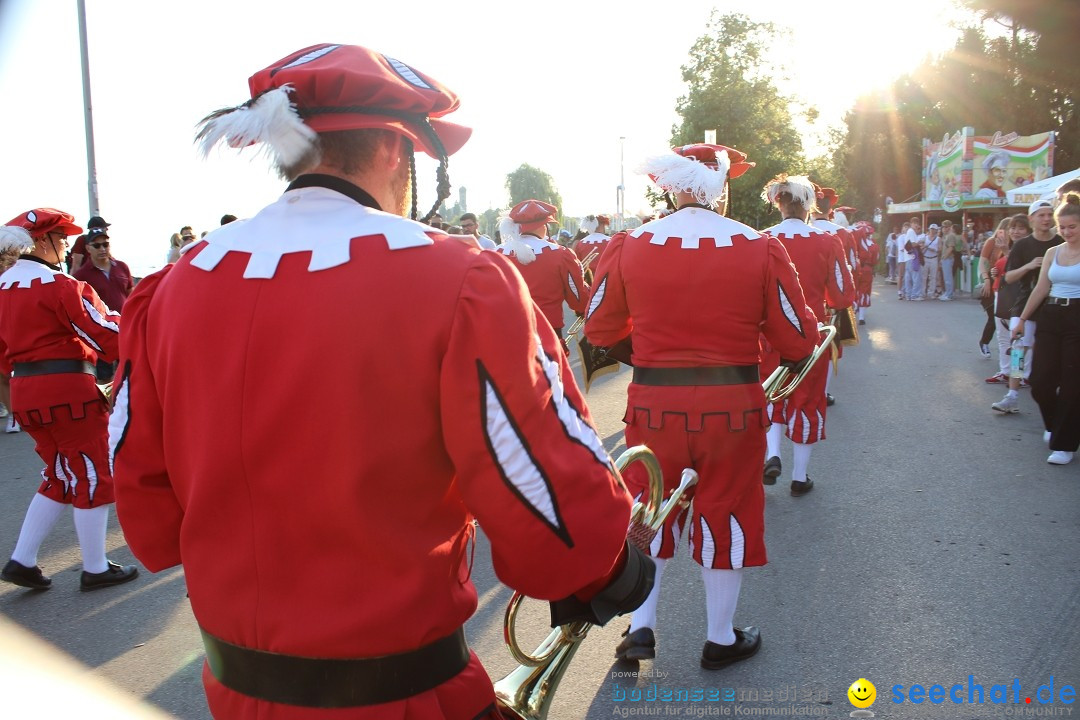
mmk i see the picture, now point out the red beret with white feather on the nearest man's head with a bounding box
[197,43,472,170]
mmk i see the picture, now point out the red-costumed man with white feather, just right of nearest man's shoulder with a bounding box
[498,200,589,337]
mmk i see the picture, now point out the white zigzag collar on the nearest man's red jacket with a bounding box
[191,187,434,279]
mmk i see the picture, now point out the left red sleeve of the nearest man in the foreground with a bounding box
[109,264,183,572]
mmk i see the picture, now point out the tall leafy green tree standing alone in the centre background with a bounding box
[672,11,804,227]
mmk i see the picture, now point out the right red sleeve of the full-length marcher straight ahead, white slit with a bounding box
[761,235,816,361]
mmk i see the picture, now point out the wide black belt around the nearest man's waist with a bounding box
[200,628,469,708]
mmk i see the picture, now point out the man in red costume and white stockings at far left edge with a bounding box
[0,207,138,590]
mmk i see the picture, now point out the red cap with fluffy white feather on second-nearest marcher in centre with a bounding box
[642,142,756,206]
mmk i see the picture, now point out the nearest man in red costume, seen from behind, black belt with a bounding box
[110,44,651,720]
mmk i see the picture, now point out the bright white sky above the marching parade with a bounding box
[0,0,957,273]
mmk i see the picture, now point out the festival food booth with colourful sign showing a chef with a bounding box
[888,127,1054,293]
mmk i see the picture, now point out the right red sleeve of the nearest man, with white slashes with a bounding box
[440,253,631,600]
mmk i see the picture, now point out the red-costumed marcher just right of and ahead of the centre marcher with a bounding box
[761,175,855,497]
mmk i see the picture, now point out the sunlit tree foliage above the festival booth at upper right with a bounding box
[838,16,1080,213]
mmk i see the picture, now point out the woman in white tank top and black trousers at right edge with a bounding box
[1013,192,1080,465]
